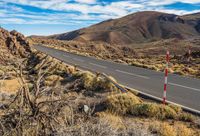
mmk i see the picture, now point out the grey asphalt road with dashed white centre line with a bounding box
[34,45,200,112]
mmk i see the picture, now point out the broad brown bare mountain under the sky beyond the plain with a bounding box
[48,11,200,44]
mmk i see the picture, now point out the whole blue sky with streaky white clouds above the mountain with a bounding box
[0,0,200,36]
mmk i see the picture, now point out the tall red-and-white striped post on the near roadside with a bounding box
[163,51,169,104]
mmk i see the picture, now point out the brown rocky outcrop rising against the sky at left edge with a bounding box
[0,28,30,57]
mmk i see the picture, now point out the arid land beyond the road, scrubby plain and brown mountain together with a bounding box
[29,11,200,78]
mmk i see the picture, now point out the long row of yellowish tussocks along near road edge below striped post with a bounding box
[106,93,194,122]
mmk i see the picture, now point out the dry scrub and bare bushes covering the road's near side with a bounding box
[0,49,200,136]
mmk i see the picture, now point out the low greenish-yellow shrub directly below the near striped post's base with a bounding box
[131,103,177,119]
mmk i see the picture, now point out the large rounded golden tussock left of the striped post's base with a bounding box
[106,93,141,115]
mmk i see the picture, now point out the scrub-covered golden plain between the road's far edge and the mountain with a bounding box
[29,38,200,78]
